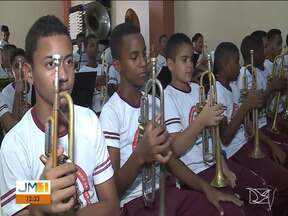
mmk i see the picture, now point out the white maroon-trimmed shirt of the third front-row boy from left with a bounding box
[164,83,211,173]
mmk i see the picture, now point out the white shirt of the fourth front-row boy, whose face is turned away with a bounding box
[216,81,247,158]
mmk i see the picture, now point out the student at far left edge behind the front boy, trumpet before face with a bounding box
[0,48,32,133]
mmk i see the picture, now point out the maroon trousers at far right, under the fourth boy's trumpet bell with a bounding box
[230,142,288,216]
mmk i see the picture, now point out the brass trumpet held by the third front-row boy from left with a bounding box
[196,54,228,188]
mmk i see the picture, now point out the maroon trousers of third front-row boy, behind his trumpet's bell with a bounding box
[199,160,270,216]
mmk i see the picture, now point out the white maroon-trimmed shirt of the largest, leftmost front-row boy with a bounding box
[0,105,113,215]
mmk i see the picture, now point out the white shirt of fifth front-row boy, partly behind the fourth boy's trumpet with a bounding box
[237,67,269,128]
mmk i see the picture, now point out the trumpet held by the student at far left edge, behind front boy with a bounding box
[14,57,29,118]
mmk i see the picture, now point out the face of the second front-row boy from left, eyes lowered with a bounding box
[114,33,148,87]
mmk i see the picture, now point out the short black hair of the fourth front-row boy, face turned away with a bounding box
[213,42,239,74]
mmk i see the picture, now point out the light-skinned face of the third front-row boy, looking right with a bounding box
[167,43,193,83]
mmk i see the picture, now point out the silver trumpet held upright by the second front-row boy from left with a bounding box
[138,57,166,216]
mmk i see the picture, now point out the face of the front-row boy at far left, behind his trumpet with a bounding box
[28,35,74,106]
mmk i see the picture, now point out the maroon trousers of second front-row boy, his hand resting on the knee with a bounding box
[121,177,245,216]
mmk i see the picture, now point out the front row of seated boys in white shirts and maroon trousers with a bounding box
[0,15,288,216]
